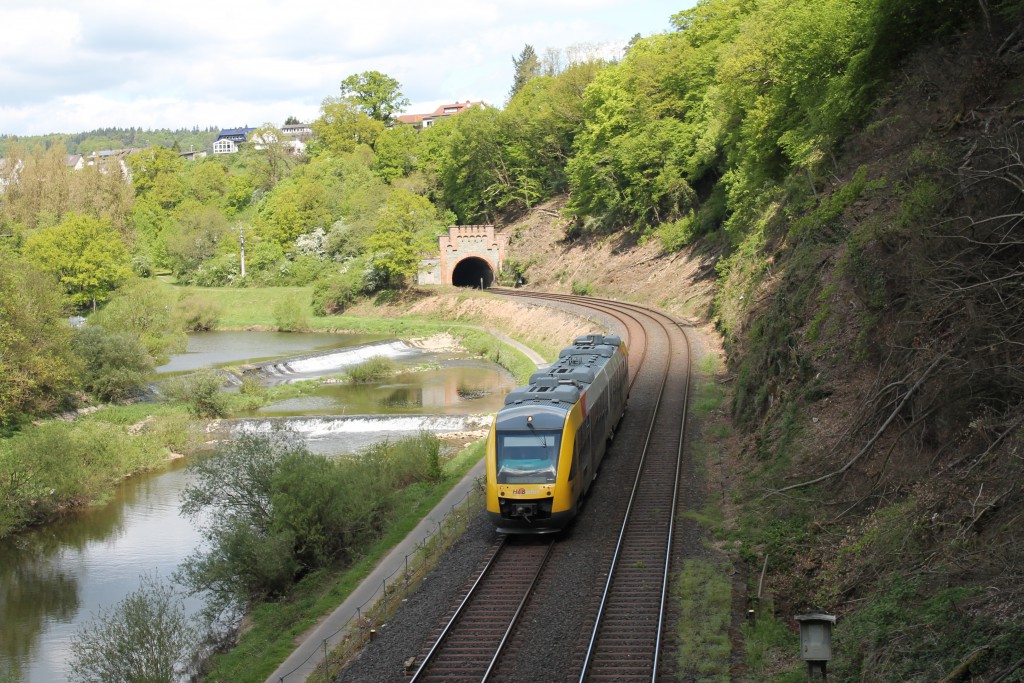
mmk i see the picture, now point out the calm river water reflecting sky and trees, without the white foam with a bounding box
[0,333,514,683]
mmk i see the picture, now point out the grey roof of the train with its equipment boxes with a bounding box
[505,335,623,410]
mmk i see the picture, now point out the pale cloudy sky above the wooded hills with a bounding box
[0,0,695,135]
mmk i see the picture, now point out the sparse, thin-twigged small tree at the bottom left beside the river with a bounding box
[71,575,200,683]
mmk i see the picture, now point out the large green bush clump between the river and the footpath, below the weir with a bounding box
[177,433,440,610]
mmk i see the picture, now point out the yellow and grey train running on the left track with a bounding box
[486,335,629,533]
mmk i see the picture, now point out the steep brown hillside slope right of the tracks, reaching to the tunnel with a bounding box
[506,24,1024,682]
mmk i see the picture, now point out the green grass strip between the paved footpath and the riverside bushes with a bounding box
[206,439,484,683]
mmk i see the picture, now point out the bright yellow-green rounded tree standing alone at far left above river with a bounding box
[25,213,131,309]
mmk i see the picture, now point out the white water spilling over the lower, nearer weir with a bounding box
[230,415,494,453]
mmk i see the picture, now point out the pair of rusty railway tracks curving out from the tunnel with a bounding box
[413,290,690,683]
